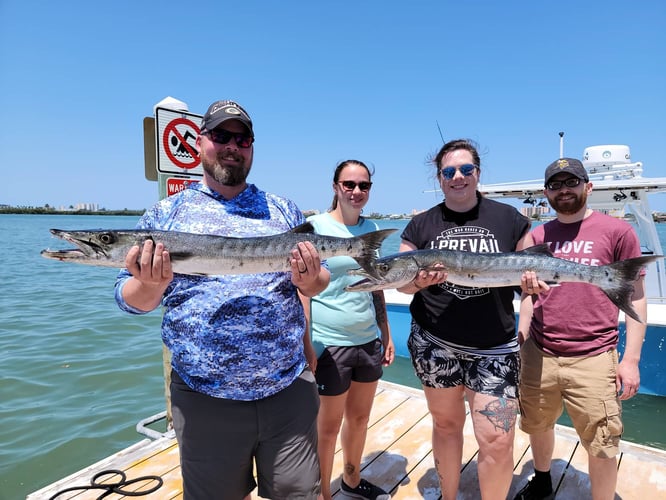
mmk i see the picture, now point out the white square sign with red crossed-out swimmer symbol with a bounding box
[155,108,203,176]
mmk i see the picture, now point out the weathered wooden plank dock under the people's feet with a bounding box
[27,380,666,500]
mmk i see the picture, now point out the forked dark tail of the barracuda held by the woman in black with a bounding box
[599,255,662,323]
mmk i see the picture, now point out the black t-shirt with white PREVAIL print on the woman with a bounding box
[402,193,529,348]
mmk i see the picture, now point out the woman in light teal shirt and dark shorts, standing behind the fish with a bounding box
[302,160,395,500]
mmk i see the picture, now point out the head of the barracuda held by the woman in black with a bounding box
[345,252,420,292]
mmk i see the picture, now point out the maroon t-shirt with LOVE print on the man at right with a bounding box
[530,212,641,356]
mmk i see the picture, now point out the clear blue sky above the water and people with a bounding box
[0,0,666,213]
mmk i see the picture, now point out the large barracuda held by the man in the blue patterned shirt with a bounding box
[41,223,396,276]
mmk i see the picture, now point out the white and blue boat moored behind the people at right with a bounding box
[385,143,666,396]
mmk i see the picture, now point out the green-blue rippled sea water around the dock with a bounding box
[0,215,666,500]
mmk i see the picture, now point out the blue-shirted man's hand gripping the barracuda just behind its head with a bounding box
[123,240,173,311]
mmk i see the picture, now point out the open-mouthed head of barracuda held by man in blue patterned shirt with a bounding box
[41,229,145,267]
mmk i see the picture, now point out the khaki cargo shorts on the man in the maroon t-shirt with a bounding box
[519,338,623,458]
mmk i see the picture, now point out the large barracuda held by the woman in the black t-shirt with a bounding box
[345,244,663,322]
